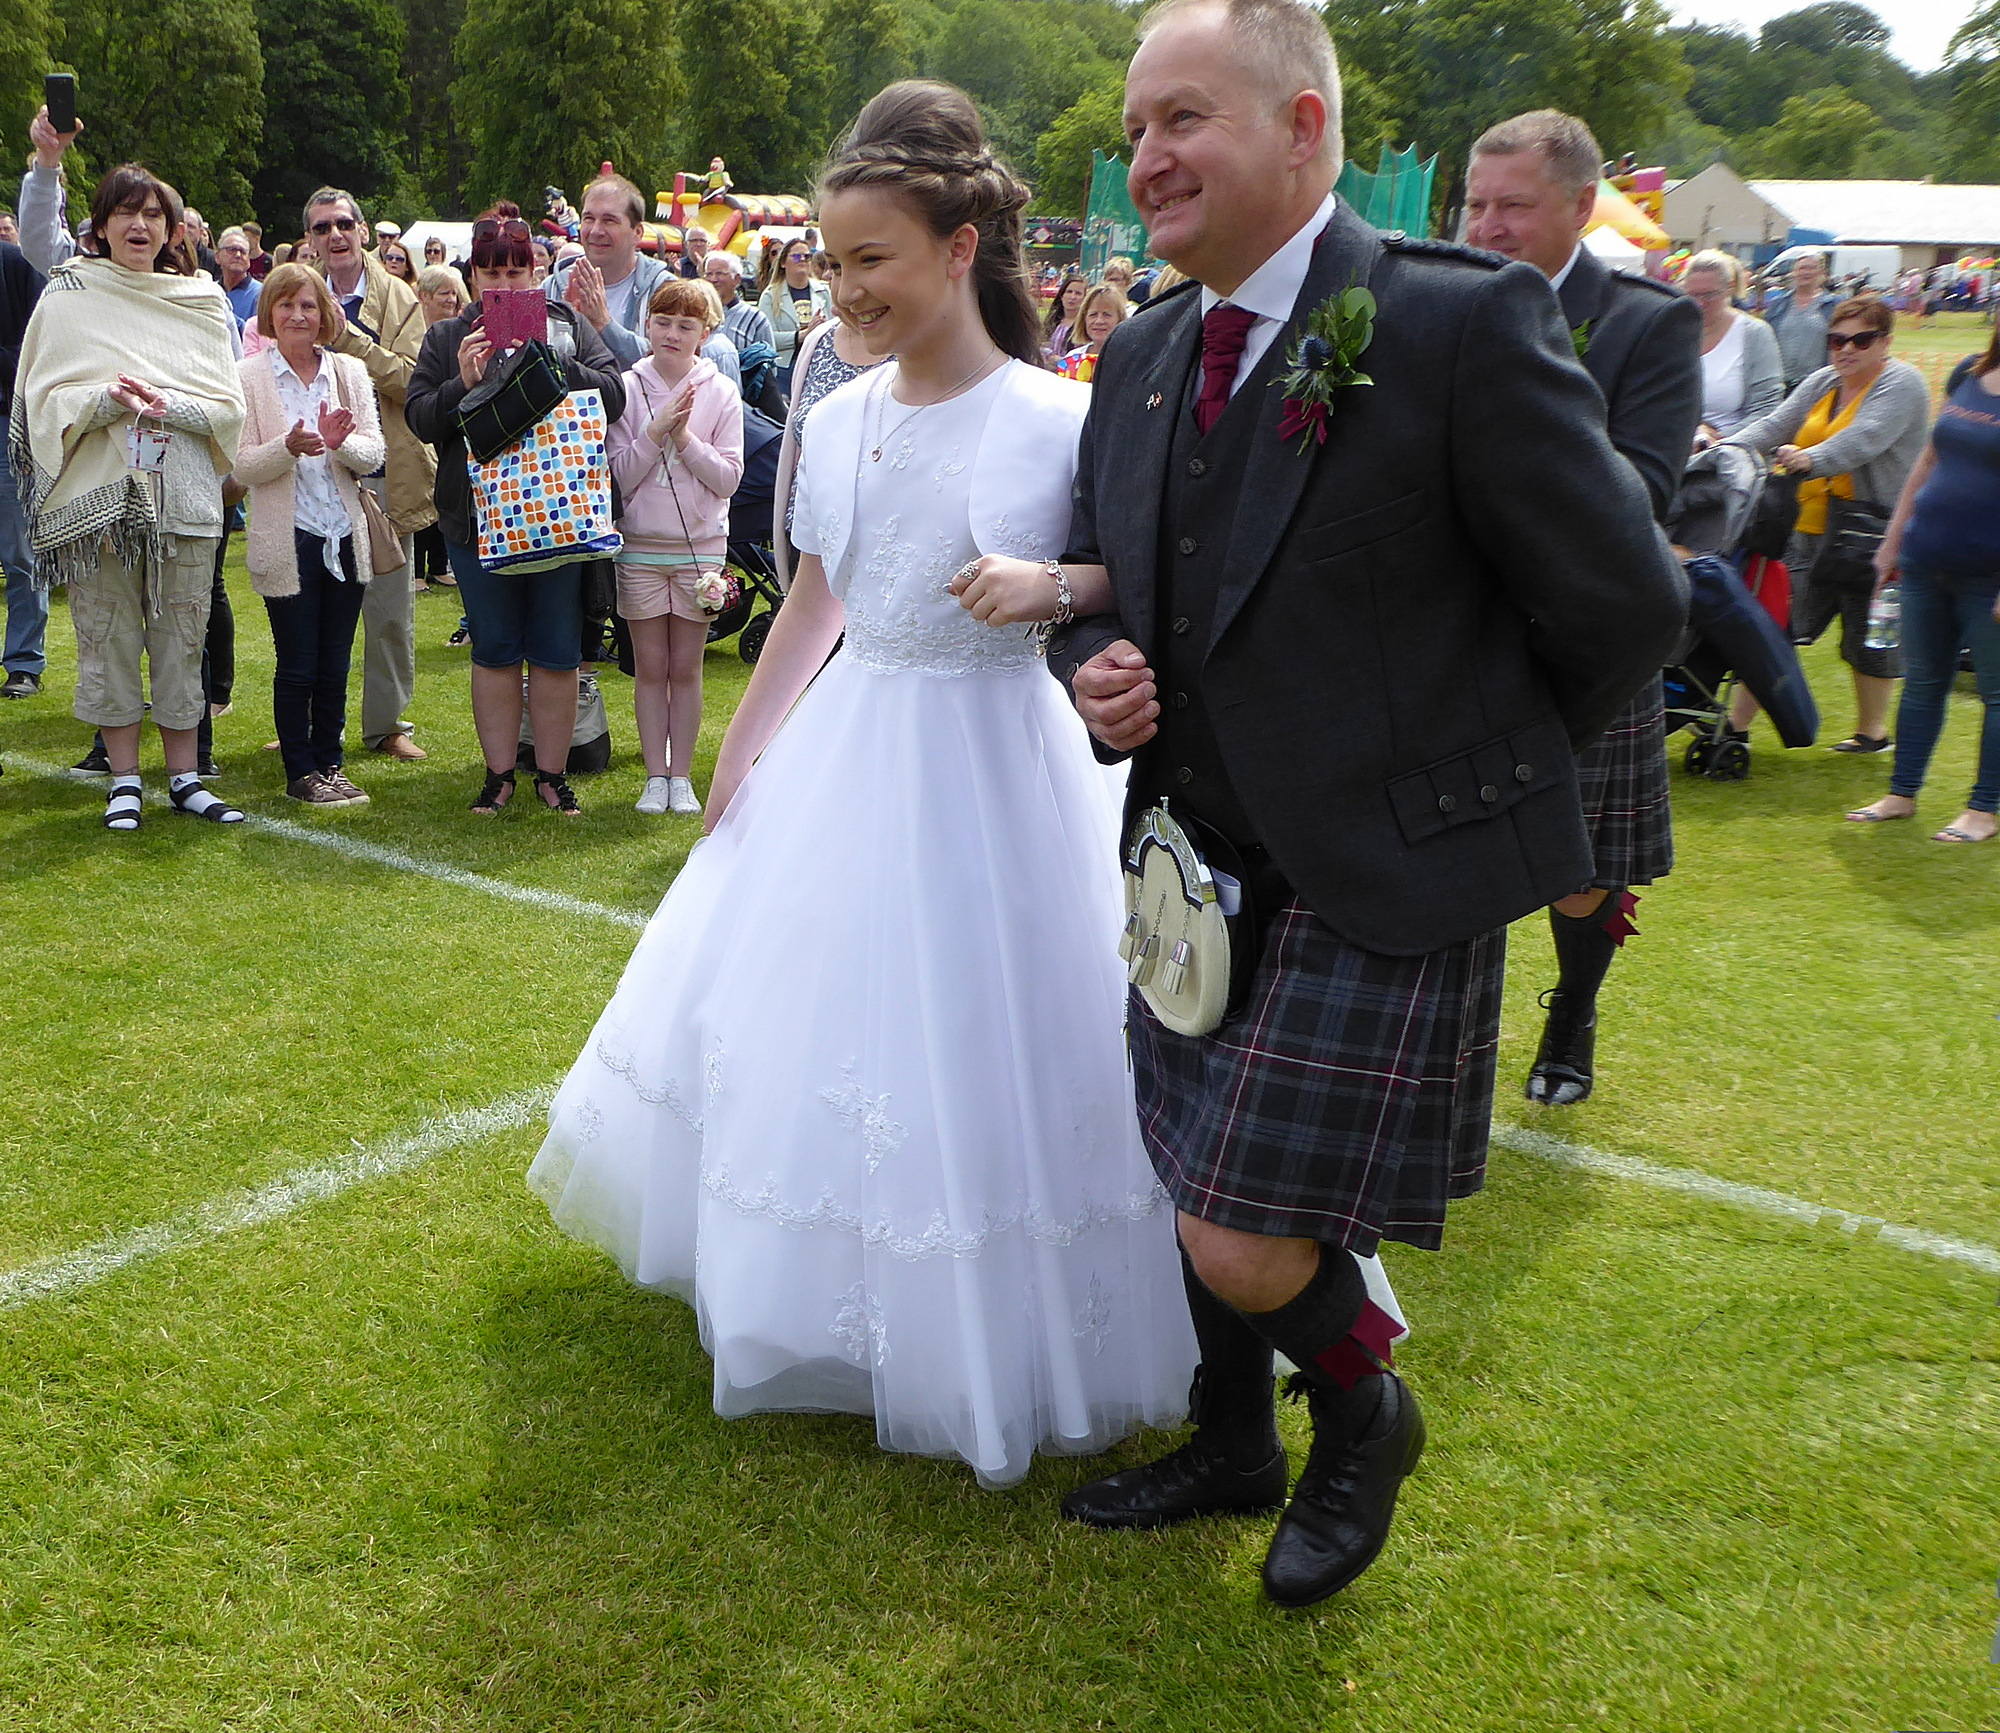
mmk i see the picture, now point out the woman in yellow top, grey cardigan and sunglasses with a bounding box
[1728,296,1930,752]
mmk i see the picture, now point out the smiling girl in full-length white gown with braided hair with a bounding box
[530,84,1194,1487]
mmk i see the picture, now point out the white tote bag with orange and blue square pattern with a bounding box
[466,388,624,572]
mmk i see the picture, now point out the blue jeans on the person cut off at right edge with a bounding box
[1888,566,2000,812]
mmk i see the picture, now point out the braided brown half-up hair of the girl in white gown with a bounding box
[820,78,1044,366]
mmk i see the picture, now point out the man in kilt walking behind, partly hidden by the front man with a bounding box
[1466,108,1702,1107]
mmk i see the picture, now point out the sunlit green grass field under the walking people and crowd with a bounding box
[0,470,2000,1733]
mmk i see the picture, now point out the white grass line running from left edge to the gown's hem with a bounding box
[0,1085,556,1311]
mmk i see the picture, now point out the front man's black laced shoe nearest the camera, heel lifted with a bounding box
[1264,1373,1424,1607]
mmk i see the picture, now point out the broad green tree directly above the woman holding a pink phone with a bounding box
[452,0,672,214]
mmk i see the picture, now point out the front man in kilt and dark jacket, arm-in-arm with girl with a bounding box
[1050,0,1686,1605]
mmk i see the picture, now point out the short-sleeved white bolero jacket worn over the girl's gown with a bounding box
[800,360,1090,588]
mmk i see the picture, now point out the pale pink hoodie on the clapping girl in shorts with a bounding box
[608,356,744,560]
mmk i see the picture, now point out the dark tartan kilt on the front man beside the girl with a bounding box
[1130,899,1506,1257]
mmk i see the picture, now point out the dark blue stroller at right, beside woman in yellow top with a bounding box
[1662,446,1820,782]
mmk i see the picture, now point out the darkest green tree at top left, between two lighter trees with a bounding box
[252,0,406,228]
